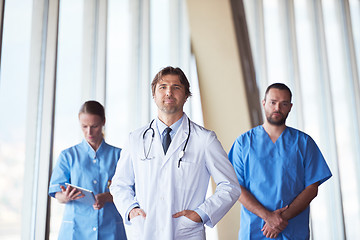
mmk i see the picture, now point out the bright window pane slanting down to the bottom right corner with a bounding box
[323,0,360,239]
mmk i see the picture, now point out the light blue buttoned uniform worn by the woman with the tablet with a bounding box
[49,140,126,240]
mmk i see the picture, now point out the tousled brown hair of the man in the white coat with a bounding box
[151,66,191,97]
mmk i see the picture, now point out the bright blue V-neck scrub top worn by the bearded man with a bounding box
[229,126,331,239]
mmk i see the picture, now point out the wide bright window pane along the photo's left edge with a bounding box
[0,0,32,240]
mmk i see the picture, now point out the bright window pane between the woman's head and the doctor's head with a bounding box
[105,0,133,147]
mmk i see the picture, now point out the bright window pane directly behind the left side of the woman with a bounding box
[50,0,83,239]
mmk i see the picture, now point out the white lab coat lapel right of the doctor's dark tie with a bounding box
[162,113,189,166]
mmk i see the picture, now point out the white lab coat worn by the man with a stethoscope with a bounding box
[110,115,240,240]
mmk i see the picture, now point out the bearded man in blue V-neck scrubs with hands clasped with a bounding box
[229,83,331,240]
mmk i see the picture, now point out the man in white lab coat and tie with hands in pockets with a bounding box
[110,67,240,240]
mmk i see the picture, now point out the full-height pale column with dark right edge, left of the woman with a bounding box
[22,0,59,239]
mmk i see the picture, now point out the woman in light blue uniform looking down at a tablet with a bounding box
[49,101,126,240]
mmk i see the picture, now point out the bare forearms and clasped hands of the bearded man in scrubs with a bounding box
[239,182,319,238]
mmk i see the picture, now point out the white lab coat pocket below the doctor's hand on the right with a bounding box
[176,216,205,239]
